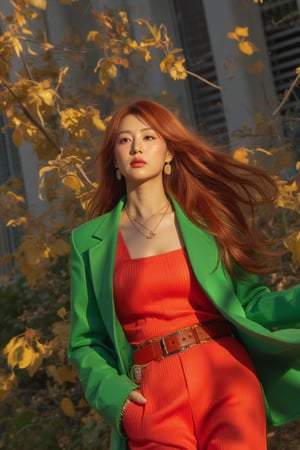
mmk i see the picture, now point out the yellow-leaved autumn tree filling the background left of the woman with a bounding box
[0,0,192,449]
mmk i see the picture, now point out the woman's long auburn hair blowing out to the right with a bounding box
[87,99,278,274]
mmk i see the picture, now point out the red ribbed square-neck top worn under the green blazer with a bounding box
[114,233,220,345]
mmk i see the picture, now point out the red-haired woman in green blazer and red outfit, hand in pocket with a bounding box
[69,100,300,450]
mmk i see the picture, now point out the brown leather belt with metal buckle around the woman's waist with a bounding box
[133,319,232,365]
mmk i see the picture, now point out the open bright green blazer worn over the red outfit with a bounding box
[68,198,300,450]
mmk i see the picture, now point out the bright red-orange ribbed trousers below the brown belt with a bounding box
[123,337,267,450]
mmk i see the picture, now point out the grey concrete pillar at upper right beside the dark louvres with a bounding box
[203,0,276,147]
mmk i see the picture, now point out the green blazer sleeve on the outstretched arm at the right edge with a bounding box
[234,274,300,331]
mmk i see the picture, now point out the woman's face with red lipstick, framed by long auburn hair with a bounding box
[114,114,172,184]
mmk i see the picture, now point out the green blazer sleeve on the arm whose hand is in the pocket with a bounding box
[68,233,137,433]
